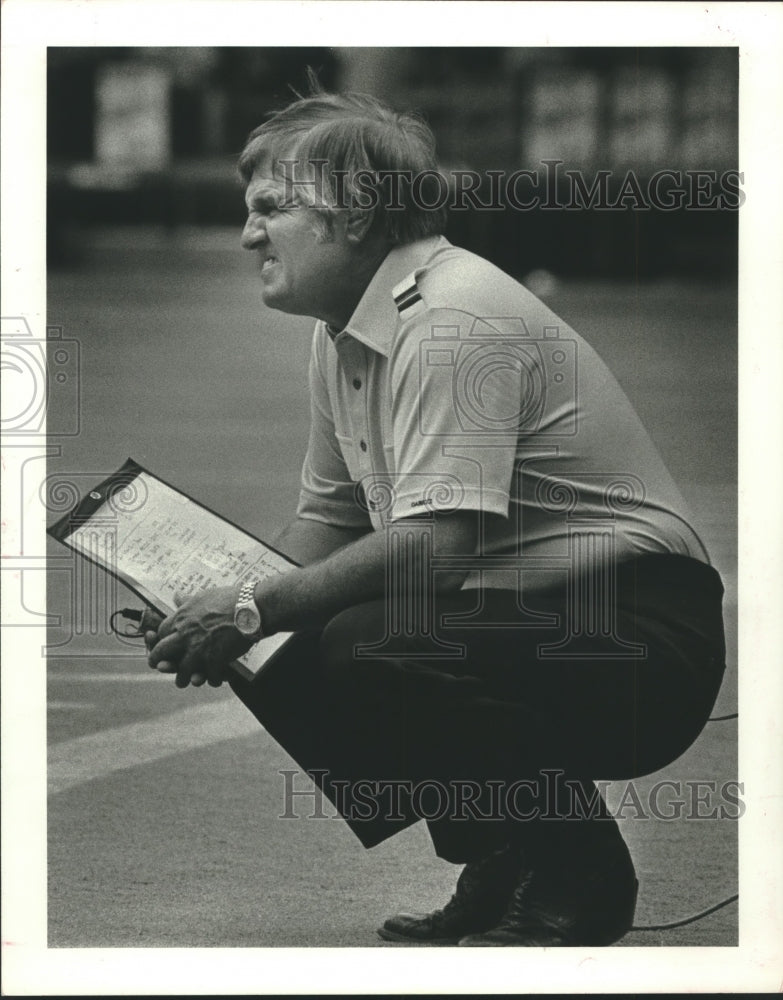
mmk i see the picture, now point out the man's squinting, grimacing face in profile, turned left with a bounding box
[242,164,354,325]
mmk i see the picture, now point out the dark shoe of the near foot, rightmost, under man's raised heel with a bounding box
[459,845,639,948]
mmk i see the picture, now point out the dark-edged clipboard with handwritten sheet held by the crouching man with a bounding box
[47,458,298,680]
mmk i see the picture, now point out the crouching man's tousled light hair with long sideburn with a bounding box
[239,86,446,244]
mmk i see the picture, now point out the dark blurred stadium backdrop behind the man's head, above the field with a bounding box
[48,48,738,277]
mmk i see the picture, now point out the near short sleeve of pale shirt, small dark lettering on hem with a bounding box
[390,309,523,519]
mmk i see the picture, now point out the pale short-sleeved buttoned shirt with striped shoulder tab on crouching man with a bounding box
[298,237,709,587]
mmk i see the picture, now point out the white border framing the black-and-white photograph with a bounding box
[2,0,783,995]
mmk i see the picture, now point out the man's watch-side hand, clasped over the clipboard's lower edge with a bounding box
[143,587,253,688]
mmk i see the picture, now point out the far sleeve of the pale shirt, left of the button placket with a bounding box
[297,324,370,528]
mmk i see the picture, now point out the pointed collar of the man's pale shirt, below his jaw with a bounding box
[334,236,450,357]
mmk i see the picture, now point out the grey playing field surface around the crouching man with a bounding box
[48,223,737,948]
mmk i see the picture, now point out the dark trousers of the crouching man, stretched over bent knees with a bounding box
[231,555,725,862]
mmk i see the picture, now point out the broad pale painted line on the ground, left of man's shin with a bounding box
[48,699,259,795]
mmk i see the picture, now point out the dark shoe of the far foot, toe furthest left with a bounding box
[378,847,522,944]
